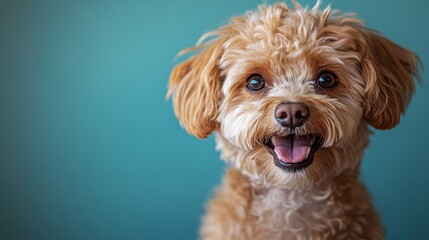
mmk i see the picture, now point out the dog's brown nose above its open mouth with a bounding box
[274,103,310,128]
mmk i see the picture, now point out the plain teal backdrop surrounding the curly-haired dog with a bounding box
[0,0,429,240]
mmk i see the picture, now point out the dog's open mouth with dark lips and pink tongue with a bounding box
[265,134,323,171]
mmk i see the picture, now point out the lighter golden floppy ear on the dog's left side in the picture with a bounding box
[167,39,224,138]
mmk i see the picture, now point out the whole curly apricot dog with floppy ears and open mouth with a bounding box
[167,1,420,240]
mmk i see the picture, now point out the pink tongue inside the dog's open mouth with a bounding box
[272,135,313,163]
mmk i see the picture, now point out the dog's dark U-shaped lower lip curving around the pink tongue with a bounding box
[265,135,323,172]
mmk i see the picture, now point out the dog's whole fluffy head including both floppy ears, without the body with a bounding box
[169,4,418,186]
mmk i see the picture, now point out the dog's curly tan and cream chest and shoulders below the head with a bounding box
[201,170,383,240]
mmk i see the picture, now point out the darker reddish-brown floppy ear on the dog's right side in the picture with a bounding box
[362,30,420,129]
